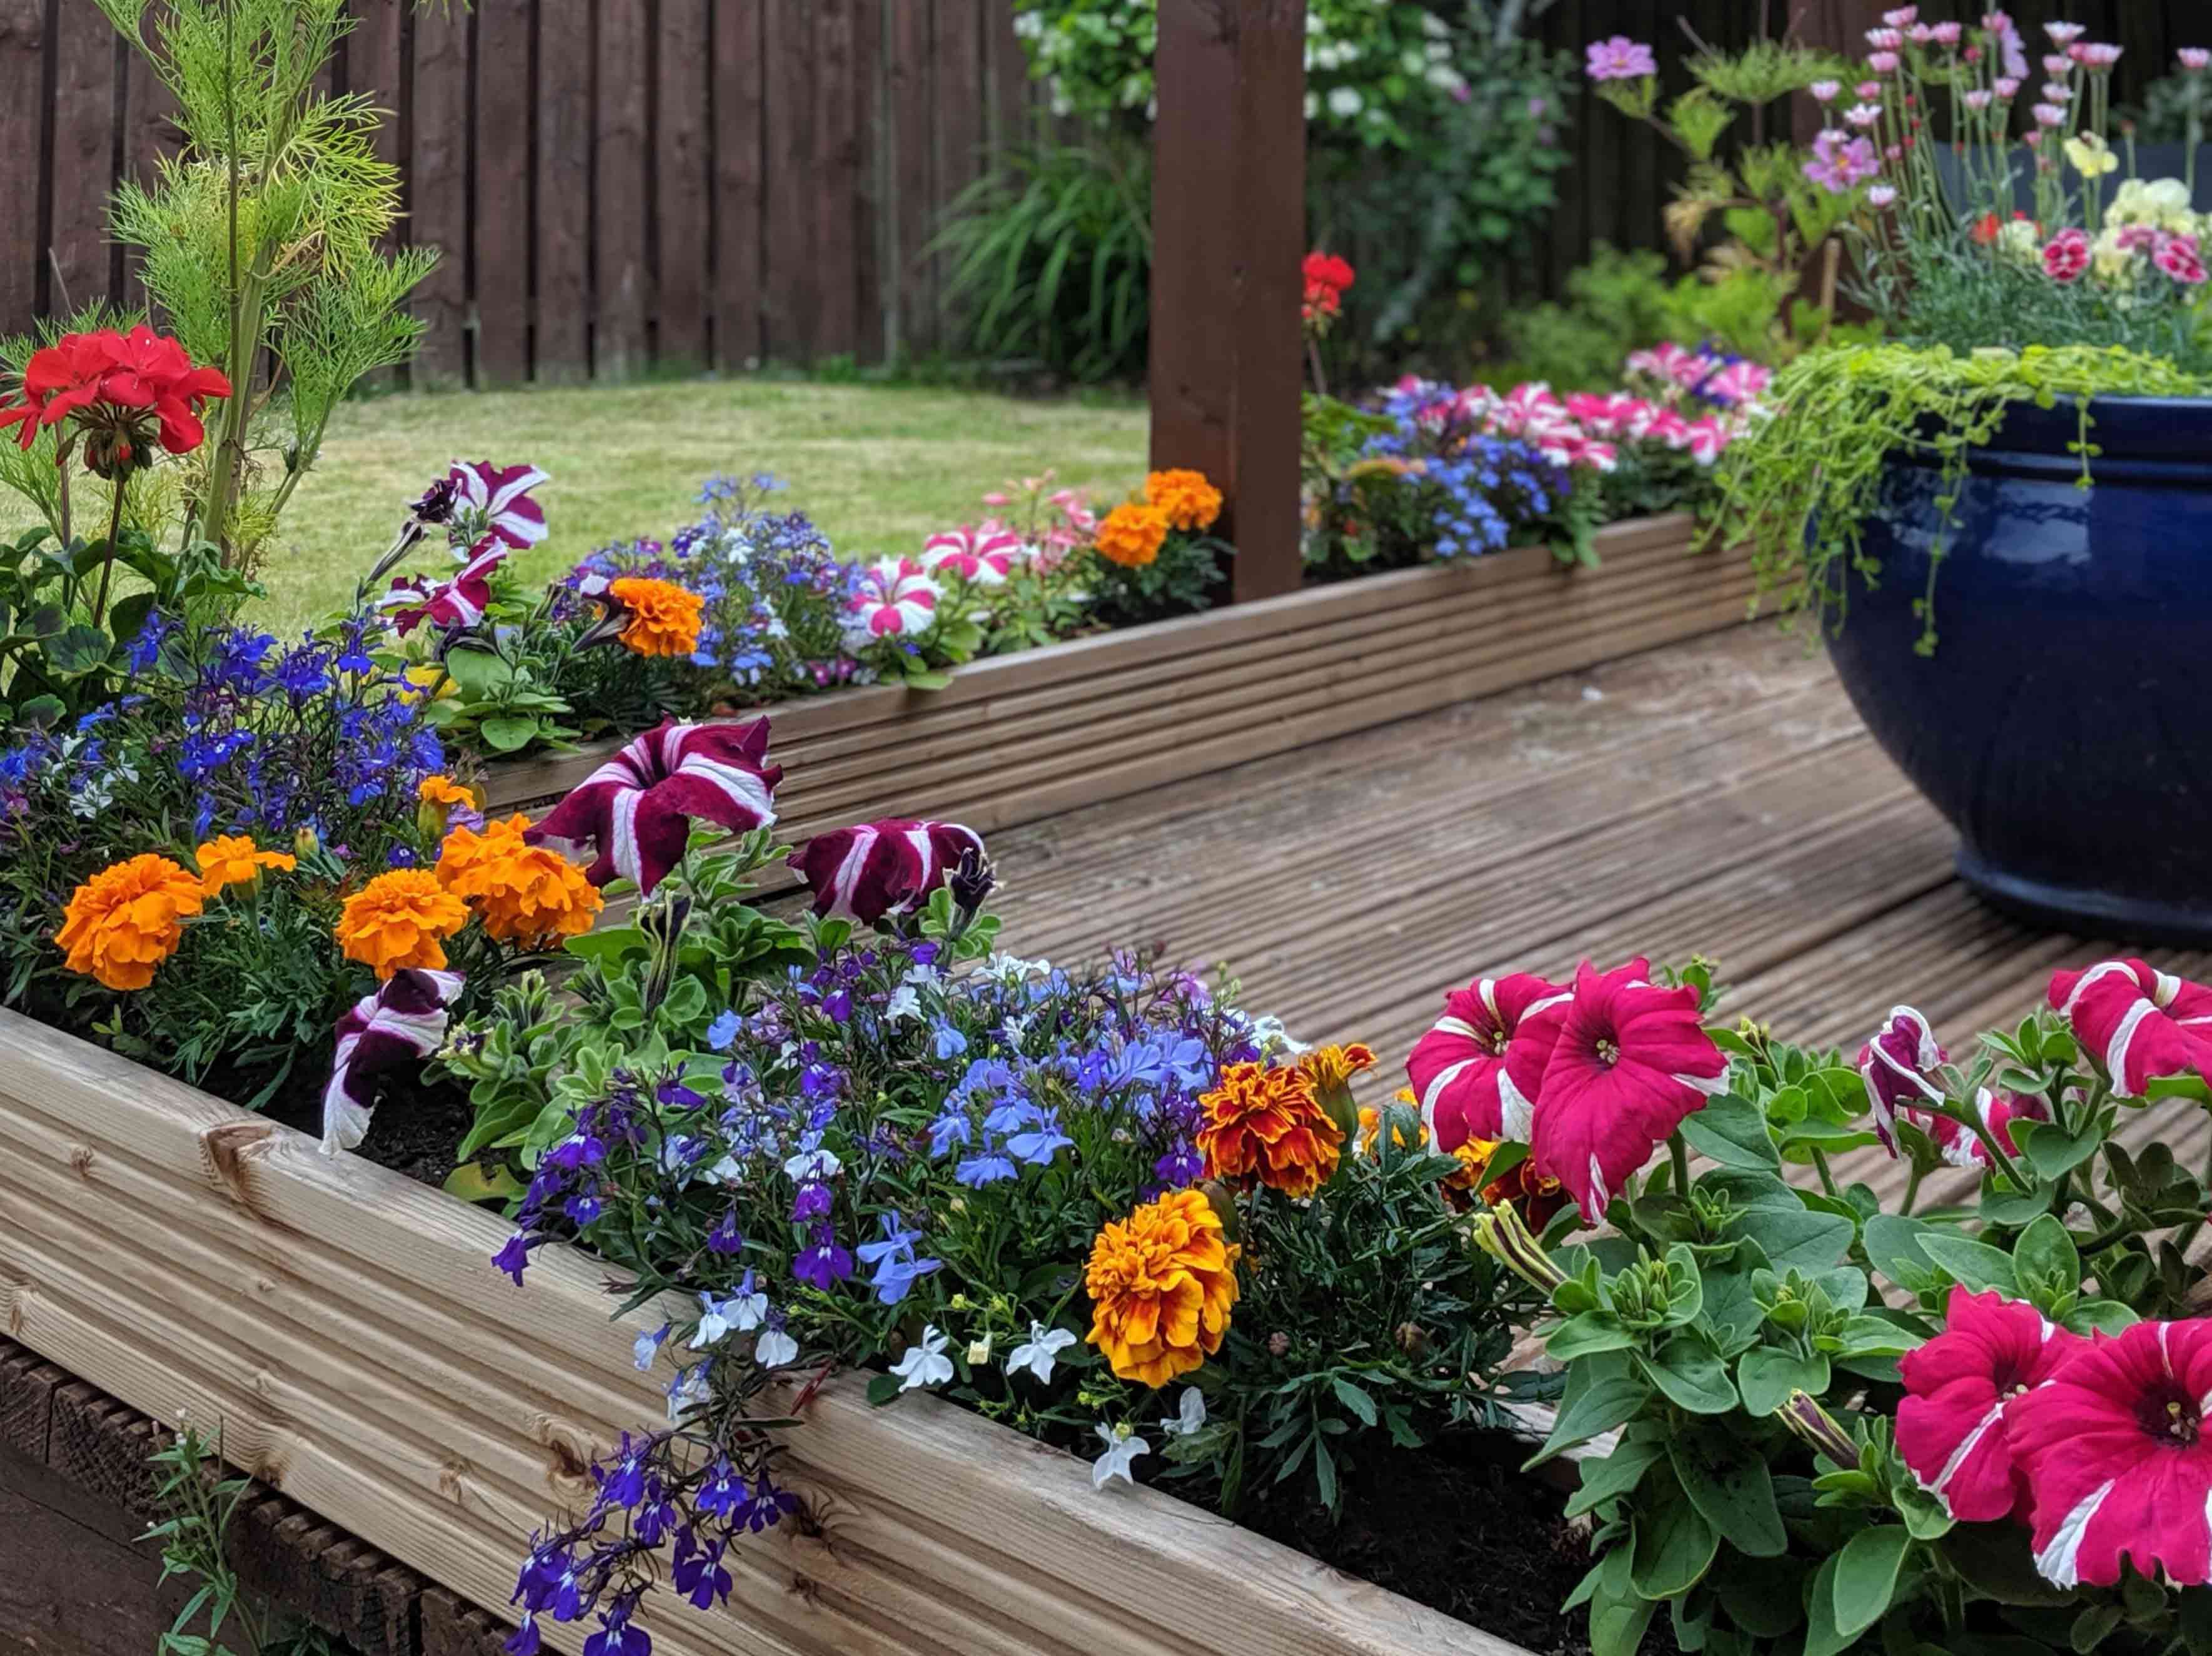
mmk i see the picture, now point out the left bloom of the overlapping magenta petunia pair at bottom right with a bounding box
[1898,1287,2088,1523]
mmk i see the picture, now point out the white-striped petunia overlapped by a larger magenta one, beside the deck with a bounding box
[1404,973,1573,1154]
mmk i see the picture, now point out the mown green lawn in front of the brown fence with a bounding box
[218,378,1146,626]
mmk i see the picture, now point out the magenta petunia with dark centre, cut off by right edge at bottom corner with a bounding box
[2004,1320,2212,1587]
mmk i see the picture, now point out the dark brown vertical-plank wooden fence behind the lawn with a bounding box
[0,0,1042,385]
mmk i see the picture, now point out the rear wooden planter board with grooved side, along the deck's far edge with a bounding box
[487,513,1752,840]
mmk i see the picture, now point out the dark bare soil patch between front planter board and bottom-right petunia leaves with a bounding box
[1239,1437,1675,1656]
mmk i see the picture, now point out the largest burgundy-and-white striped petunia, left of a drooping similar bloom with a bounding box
[527,719,783,891]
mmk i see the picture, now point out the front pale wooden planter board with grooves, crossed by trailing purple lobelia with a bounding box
[0,1012,1518,1656]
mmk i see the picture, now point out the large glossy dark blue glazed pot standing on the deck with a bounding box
[1829,398,2212,946]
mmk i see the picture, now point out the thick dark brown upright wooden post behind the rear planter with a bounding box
[1150,0,1305,599]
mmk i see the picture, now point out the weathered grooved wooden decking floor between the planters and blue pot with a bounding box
[991,626,2212,1194]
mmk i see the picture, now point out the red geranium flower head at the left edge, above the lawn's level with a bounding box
[0,323,230,480]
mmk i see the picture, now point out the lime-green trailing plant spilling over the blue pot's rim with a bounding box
[1708,345,2205,654]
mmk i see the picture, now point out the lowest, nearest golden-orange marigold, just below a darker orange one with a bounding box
[1084,1189,1239,1386]
